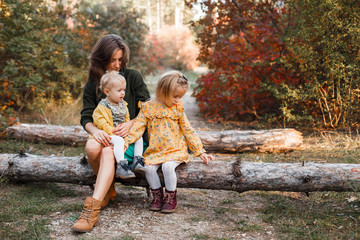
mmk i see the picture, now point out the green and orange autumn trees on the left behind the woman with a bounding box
[0,0,153,117]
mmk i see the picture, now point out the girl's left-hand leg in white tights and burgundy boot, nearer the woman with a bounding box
[145,164,164,211]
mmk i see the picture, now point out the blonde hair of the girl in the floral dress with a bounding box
[155,71,189,102]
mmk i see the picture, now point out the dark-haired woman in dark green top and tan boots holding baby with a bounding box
[72,34,150,232]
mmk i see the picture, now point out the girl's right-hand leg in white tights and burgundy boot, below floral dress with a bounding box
[161,161,181,213]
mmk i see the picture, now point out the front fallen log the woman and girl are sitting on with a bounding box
[0,154,360,192]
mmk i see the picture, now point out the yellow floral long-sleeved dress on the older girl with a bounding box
[125,100,205,165]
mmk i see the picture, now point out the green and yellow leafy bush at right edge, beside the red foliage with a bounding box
[270,0,360,128]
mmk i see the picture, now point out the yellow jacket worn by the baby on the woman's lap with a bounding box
[90,102,130,138]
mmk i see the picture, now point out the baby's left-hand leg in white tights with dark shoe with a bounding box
[111,135,135,179]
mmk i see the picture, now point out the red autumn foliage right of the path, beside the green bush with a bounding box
[187,0,298,120]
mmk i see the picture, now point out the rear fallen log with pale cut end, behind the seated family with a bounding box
[7,123,303,152]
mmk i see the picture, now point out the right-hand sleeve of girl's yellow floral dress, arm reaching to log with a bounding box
[179,111,205,157]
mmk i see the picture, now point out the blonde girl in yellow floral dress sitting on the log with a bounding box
[125,71,214,213]
